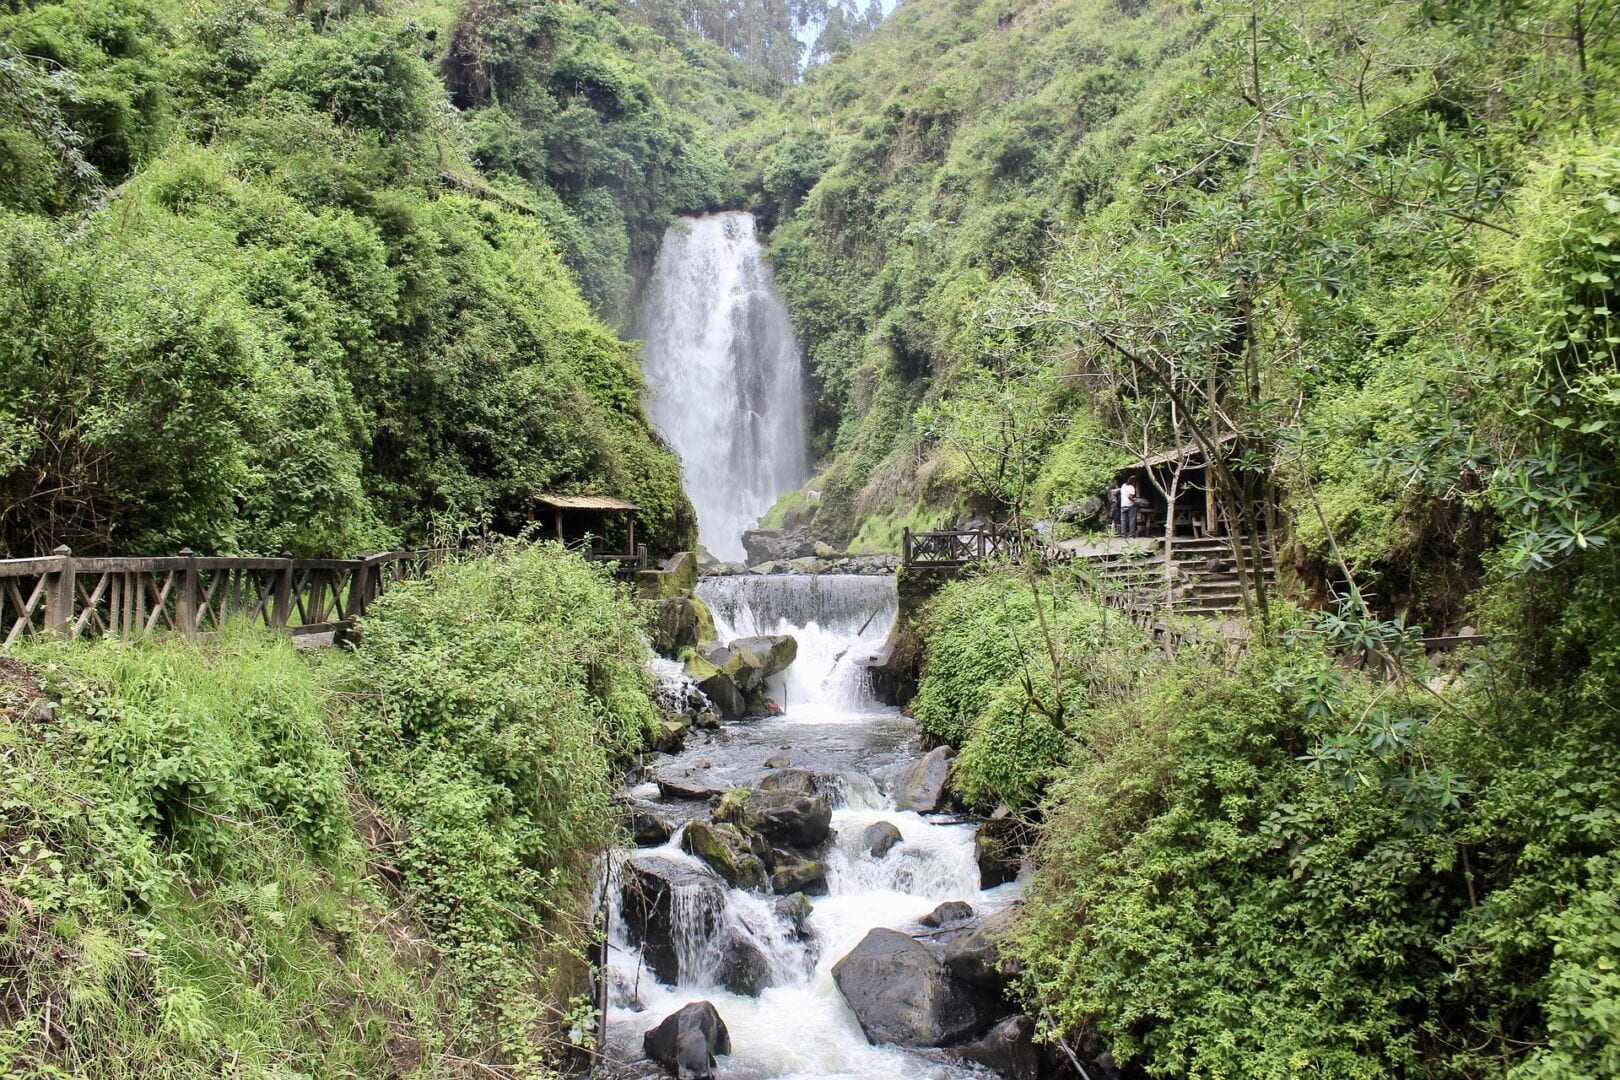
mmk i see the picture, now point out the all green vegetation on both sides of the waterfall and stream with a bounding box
[0,0,1620,1077]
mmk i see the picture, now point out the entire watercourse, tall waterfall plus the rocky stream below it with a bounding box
[604,214,1019,1080]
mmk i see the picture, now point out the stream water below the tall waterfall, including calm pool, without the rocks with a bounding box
[601,576,1019,1080]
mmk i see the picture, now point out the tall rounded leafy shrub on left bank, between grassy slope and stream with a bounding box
[334,544,654,1061]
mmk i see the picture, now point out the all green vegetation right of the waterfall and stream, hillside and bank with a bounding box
[797,2,1620,1077]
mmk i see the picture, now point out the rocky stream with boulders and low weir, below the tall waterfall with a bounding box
[606,575,1053,1080]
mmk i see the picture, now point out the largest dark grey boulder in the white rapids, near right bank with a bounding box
[833,926,990,1046]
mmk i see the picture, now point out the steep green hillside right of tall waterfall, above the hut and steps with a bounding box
[745,0,1615,592]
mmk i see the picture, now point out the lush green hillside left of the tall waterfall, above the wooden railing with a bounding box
[0,0,719,554]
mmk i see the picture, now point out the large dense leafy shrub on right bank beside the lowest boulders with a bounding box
[1016,654,1468,1077]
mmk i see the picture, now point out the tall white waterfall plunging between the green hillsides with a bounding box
[642,212,808,559]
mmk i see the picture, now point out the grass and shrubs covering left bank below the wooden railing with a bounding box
[0,546,651,1077]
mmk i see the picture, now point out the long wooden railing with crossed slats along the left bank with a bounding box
[0,547,449,646]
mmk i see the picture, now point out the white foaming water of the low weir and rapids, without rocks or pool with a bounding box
[609,575,1017,1080]
